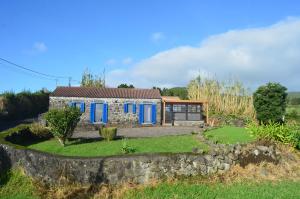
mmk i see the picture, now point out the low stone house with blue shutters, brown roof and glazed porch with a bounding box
[49,87,207,129]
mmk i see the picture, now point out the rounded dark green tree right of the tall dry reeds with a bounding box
[253,83,287,124]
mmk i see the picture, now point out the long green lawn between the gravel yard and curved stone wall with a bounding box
[28,135,208,156]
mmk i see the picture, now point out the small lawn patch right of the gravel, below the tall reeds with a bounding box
[205,126,255,144]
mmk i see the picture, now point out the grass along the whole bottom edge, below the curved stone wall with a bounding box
[0,170,300,199]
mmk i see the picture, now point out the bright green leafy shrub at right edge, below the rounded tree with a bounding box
[246,122,300,148]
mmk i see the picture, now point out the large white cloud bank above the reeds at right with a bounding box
[108,18,300,90]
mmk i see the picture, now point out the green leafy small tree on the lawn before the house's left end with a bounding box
[45,106,81,146]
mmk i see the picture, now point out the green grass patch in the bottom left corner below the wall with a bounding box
[0,169,38,199]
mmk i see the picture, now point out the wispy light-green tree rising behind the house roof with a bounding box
[80,68,105,88]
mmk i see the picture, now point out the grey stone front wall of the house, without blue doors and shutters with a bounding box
[49,97,161,129]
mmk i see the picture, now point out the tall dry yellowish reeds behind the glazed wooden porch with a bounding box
[188,76,255,119]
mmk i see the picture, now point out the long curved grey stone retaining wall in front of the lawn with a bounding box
[0,141,277,184]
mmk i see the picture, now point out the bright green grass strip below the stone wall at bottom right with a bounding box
[124,181,300,199]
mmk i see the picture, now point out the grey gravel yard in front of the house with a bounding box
[73,127,203,138]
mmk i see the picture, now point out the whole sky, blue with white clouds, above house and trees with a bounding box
[0,0,300,92]
